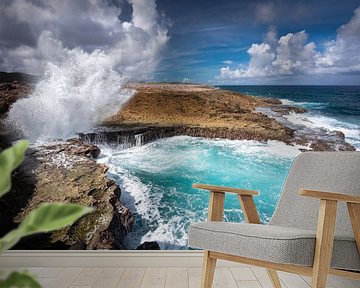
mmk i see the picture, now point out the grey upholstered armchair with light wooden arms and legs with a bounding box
[189,152,360,288]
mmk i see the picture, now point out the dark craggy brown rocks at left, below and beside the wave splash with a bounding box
[0,78,134,250]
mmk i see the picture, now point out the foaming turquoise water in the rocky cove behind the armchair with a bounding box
[99,136,299,249]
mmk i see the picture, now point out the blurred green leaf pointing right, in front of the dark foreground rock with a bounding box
[0,203,93,251]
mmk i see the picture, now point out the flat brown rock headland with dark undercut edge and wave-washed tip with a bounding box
[86,83,355,151]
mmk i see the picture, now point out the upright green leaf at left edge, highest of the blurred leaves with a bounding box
[0,140,29,197]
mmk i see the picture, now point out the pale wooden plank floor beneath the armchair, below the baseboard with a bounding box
[2,266,360,288]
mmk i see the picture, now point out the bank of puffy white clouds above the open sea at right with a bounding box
[218,7,360,80]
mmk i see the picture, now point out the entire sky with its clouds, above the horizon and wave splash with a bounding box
[0,0,360,85]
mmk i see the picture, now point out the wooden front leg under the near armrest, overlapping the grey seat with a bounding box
[311,200,337,288]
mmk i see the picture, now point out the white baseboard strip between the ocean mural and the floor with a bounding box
[0,250,248,267]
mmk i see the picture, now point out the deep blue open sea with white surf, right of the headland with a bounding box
[217,85,360,150]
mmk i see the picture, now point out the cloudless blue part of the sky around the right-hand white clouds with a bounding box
[155,0,360,84]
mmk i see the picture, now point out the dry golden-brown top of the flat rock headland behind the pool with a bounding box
[104,84,292,142]
